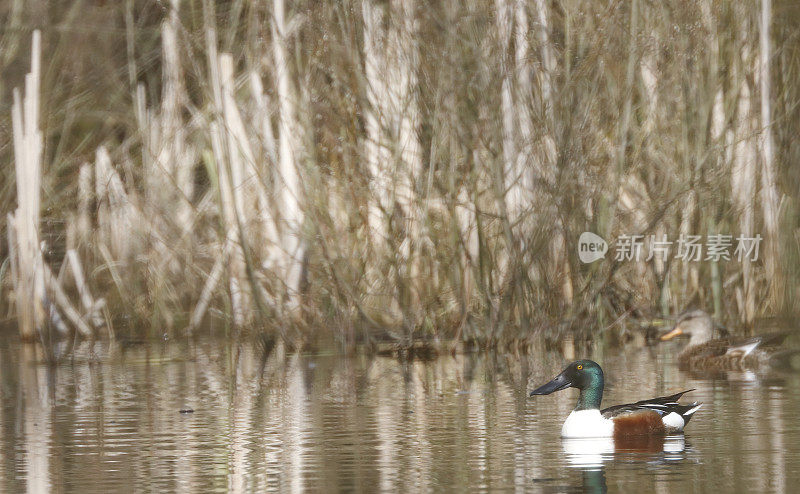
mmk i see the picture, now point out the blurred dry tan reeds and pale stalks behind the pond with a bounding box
[0,0,800,348]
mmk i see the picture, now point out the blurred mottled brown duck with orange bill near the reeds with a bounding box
[661,310,787,371]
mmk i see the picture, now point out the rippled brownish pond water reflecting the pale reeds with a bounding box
[0,341,800,493]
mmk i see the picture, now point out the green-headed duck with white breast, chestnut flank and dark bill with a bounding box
[530,360,701,439]
